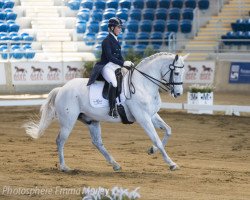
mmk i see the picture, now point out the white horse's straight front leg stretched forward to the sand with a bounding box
[136,113,179,170]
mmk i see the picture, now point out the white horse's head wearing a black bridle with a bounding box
[163,54,189,98]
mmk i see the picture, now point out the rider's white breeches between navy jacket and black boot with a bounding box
[102,62,121,87]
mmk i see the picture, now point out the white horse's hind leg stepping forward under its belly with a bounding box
[81,119,121,171]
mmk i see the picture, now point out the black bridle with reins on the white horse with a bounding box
[126,55,184,99]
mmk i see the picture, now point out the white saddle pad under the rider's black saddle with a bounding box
[89,81,126,108]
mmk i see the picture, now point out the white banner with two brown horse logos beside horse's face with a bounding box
[184,61,215,84]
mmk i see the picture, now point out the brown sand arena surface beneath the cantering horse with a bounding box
[0,92,250,200]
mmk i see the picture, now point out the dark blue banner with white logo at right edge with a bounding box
[229,62,250,83]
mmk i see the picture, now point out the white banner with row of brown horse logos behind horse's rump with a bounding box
[11,62,83,85]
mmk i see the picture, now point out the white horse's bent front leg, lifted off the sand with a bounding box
[148,113,171,155]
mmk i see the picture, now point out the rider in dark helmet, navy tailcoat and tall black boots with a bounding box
[87,17,134,118]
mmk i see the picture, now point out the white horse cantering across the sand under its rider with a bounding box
[24,52,188,171]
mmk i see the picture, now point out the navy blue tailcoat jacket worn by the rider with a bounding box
[87,34,124,85]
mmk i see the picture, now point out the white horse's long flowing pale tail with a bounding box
[24,87,60,139]
